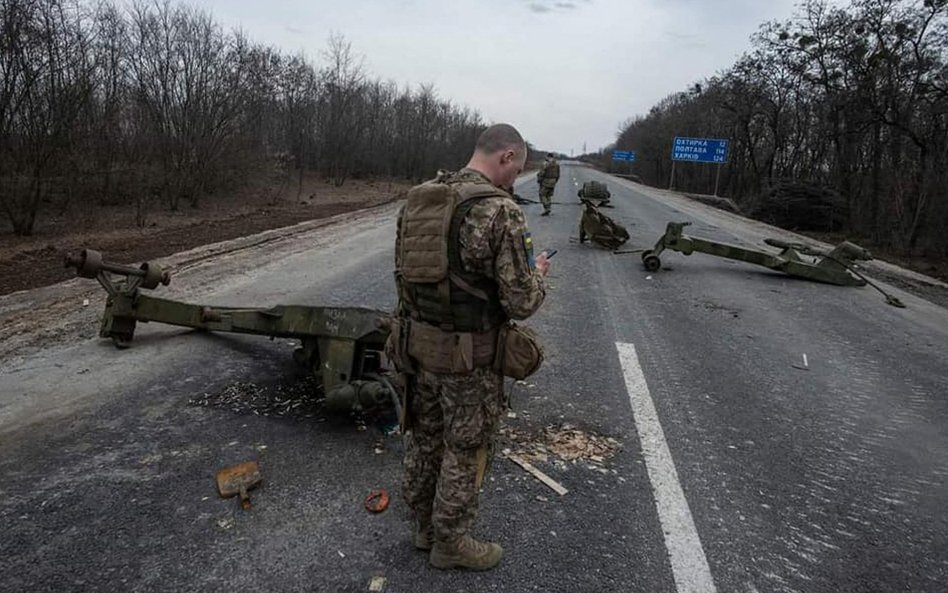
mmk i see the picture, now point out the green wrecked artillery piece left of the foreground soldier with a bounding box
[66,249,399,411]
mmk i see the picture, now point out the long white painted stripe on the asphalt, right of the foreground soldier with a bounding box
[616,342,717,593]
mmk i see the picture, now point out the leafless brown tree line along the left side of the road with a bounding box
[0,0,486,235]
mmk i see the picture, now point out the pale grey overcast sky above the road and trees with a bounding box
[185,0,796,154]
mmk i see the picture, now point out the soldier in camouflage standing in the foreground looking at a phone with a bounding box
[390,124,549,570]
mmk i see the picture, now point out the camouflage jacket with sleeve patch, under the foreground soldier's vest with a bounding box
[395,169,546,319]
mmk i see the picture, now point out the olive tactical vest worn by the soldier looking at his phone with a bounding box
[395,174,507,332]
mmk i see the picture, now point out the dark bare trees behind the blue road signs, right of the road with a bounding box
[599,0,948,257]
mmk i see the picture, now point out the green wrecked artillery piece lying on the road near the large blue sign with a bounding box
[642,222,905,307]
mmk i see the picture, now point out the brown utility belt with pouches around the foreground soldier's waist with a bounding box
[386,318,543,379]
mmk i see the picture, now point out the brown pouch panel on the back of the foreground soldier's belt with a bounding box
[405,319,498,374]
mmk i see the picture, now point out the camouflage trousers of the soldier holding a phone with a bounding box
[402,368,504,542]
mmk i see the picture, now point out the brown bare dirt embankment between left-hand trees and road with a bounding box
[0,180,410,295]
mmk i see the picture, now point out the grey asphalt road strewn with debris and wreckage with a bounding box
[0,164,948,593]
